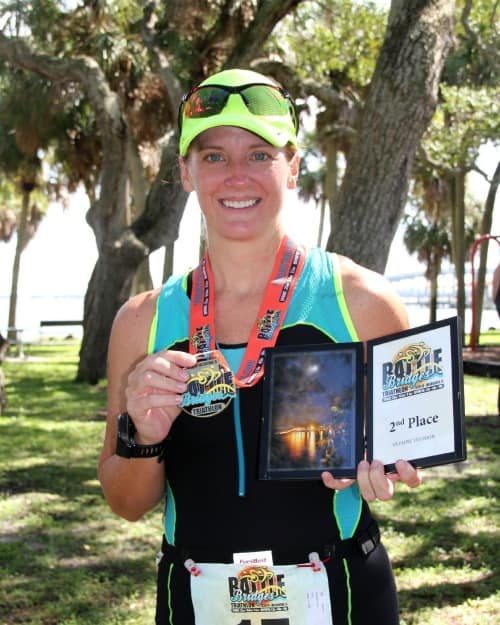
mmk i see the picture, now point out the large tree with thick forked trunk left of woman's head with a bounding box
[0,0,302,382]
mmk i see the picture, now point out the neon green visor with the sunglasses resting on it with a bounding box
[178,69,298,156]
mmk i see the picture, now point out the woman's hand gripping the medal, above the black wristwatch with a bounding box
[125,350,196,445]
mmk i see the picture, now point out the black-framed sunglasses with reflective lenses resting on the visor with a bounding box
[178,82,299,134]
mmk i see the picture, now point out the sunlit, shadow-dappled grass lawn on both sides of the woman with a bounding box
[0,343,500,625]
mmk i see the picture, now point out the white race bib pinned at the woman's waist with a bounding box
[191,562,333,625]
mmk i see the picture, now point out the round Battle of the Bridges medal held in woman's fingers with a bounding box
[181,350,236,417]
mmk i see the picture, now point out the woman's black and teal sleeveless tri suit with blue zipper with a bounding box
[149,249,399,625]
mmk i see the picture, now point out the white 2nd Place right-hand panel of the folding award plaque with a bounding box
[367,317,466,471]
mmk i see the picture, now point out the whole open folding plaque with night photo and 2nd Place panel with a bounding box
[259,317,466,480]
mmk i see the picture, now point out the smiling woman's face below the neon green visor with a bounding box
[180,126,299,240]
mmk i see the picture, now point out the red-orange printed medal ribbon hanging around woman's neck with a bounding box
[189,236,305,387]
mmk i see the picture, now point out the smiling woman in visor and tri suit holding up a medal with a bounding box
[99,70,420,625]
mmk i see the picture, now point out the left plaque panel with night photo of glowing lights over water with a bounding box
[259,343,364,479]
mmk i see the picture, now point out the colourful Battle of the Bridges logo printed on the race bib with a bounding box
[228,566,288,612]
